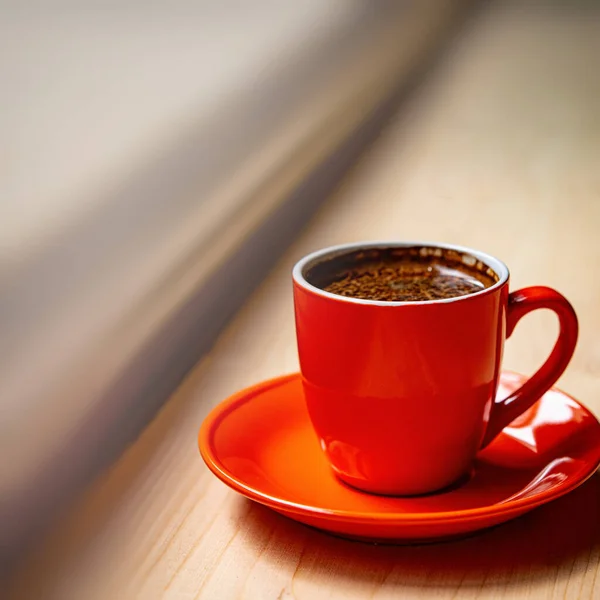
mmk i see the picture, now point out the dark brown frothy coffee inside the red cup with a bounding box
[306,247,498,302]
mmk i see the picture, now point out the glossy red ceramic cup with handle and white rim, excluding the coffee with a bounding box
[293,242,578,495]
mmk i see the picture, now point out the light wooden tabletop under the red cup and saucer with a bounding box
[12,3,600,600]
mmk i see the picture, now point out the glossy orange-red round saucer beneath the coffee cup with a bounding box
[199,372,600,542]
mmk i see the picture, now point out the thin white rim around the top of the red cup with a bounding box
[292,240,510,307]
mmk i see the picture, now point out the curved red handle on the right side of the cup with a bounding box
[481,286,579,448]
